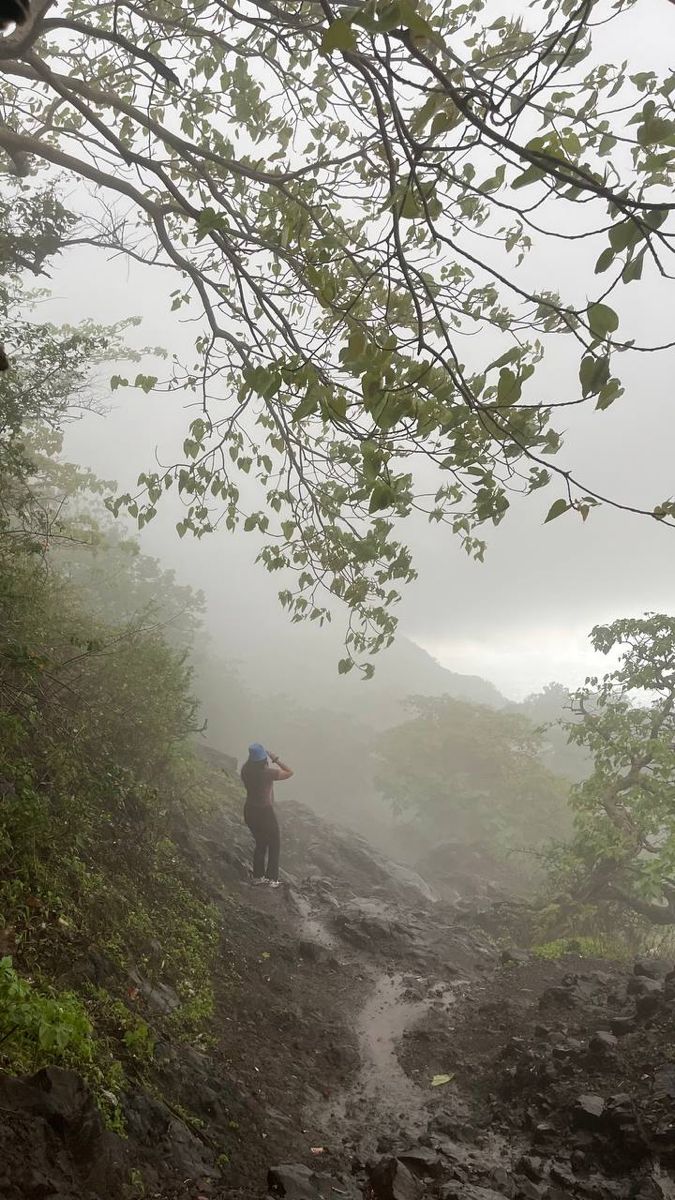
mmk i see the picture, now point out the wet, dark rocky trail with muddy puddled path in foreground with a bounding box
[0,758,675,1200]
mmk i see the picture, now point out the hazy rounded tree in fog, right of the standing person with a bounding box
[377,698,567,854]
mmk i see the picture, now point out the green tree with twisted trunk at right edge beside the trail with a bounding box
[556,613,675,925]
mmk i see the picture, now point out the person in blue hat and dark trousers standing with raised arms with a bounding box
[241,742,293,888]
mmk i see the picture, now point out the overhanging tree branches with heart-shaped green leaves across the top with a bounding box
[0,0,675,671]
